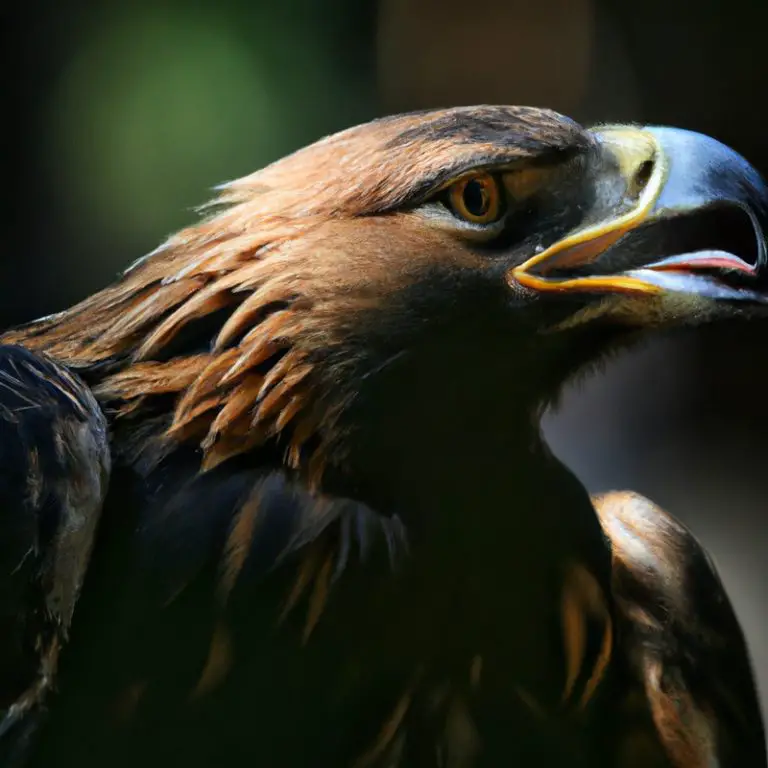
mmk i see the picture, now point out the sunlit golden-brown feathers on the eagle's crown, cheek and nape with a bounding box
[3,108,584,486]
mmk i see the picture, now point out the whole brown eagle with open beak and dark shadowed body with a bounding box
[0,106,768,768]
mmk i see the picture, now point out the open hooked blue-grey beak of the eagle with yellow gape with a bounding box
[509,126,768,303]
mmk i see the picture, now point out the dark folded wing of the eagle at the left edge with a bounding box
[0,346,110,765]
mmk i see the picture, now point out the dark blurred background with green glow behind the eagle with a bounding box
[7,0,768,708]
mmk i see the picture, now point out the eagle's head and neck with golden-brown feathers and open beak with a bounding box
[5,106,768,496]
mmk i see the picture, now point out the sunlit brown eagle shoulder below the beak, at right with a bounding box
[593,492,767,768]
